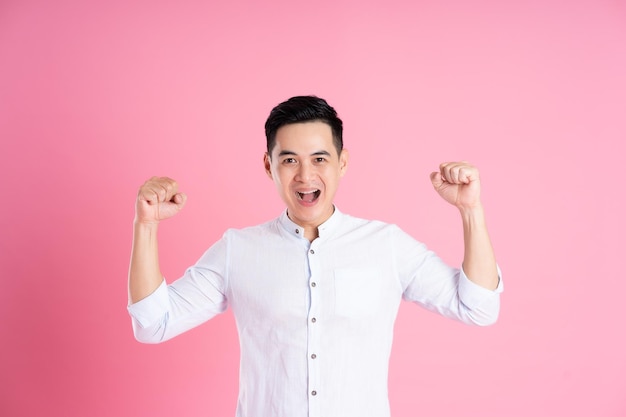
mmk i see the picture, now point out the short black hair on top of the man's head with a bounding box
[265,96,343,156]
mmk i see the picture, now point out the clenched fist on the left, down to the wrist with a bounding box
[135,177,187,224]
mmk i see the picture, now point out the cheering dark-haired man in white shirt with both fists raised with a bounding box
[129,96,501,417]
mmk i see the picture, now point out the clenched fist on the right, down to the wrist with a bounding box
[430,161,480,210]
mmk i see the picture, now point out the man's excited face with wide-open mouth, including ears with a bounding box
[265,122,348,229]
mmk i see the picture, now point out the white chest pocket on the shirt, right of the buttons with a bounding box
[334,268,389,318]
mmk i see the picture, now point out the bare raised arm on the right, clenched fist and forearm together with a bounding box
[430,162,498,289]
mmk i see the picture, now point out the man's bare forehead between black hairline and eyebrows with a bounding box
[272,121,337,155]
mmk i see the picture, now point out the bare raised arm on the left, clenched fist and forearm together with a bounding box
[128,177,187,304]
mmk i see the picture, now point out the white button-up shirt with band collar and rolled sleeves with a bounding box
[129,209,502,417]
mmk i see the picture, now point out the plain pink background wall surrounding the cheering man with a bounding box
[0,0,626,417]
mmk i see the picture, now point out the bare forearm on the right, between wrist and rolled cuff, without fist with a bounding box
[460,206,499,290]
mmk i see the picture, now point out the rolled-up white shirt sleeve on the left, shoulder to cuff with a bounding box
[128,232,228,343]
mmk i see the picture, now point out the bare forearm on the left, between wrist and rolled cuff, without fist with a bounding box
[128,222,163,304]
